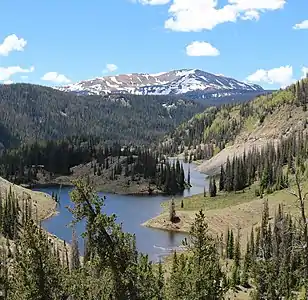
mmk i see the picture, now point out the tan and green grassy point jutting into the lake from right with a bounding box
[142,190,298,247]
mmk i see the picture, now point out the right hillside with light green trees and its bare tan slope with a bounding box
[161,78,308,173]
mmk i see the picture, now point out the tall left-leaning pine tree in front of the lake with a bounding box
[71,181,155,299]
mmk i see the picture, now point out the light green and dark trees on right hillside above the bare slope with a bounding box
[160,78,308,161]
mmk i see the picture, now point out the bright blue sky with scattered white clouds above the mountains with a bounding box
[0,0,308,89]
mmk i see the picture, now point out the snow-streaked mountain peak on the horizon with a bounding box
[56,69,265,102]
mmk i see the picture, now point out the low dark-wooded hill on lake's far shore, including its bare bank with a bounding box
[0,136,189,195]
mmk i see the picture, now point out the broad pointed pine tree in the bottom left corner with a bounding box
[8,221,65,300]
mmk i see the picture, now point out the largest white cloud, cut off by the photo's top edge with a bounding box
[165,0,286,32]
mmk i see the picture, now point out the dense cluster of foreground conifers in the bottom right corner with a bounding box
[220,201,308,299]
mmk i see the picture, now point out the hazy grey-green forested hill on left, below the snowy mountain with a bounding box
[0,84,204,148]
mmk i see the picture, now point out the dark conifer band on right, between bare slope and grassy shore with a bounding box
[210,132,308,195]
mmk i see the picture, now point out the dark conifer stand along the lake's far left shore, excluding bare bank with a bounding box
[0,136,187,194]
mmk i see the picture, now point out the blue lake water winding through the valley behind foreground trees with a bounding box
[34,164,208,261]
